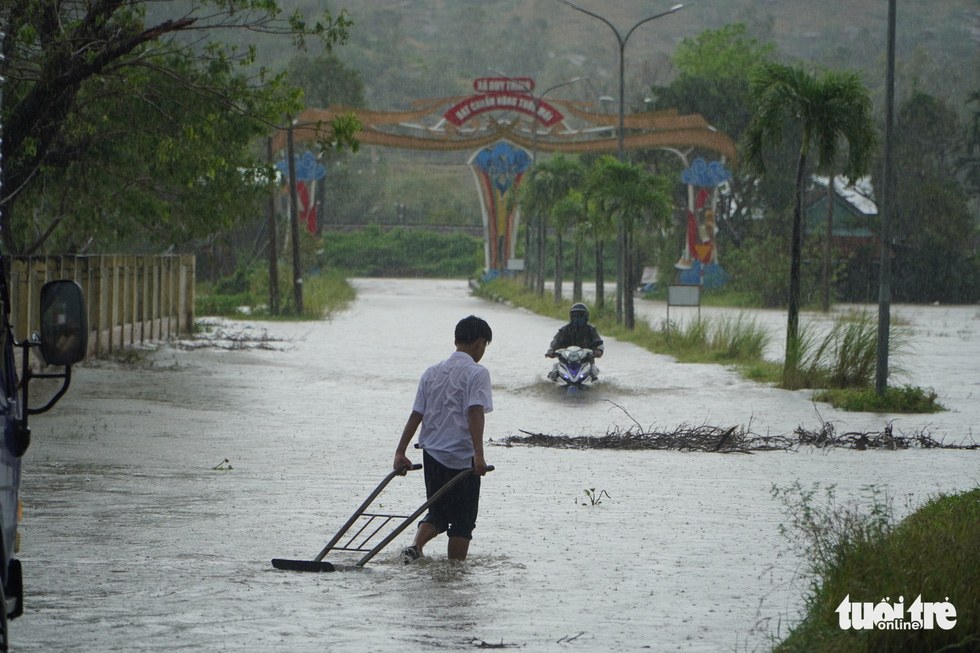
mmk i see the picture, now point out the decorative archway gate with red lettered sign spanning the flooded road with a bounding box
[273,77,736,272]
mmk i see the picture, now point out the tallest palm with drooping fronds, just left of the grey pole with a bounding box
[742,64,878,387]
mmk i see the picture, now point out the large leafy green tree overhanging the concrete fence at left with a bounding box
[0,0,350,253]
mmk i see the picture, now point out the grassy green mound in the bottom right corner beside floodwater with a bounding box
[773,483,980,653]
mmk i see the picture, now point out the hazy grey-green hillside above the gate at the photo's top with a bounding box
[270,0,980,110]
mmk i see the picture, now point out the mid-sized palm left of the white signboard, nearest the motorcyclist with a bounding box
[586,156,671,329]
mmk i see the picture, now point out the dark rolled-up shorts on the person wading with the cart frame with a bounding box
[422,451,480,540]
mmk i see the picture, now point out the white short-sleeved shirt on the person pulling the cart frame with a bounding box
[412,351,493,469]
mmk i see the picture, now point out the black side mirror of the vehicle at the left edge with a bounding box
[40,280,88,365]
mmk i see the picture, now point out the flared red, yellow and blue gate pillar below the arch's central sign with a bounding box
[469,141,531,276]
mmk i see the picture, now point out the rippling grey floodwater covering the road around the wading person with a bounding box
[12,280,980,652]
